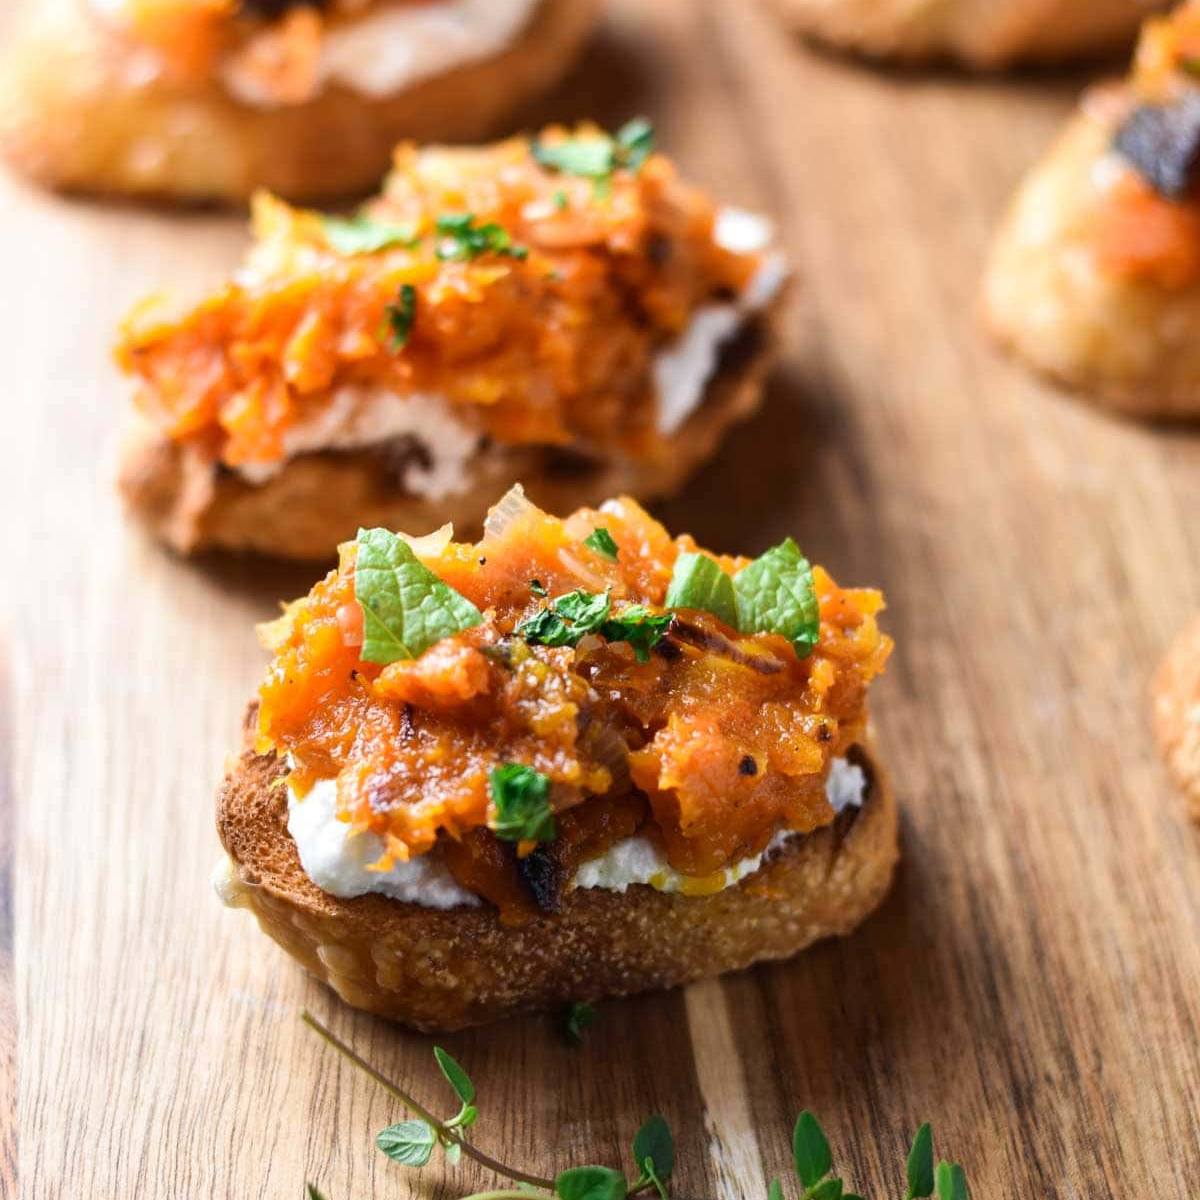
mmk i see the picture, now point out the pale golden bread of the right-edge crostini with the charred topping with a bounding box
[984,97,1200,419]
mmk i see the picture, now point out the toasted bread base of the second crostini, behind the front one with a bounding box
[119,300,786,560]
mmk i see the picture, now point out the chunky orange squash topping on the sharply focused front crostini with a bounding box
[258,492,890,913]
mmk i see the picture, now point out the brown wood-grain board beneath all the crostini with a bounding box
[0,0,1200,1200]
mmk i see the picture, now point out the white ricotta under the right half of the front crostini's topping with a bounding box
[575,758,866,893]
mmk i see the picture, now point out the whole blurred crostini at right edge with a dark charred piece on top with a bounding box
[984,2,1200,418]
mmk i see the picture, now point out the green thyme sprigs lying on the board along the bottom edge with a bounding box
[300,1006,970,1200]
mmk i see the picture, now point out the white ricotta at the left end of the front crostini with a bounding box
[288,779,480,908]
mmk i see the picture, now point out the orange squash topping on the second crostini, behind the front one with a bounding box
[118,127,761,467]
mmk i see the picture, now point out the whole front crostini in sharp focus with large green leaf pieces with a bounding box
[217,487,896,1030]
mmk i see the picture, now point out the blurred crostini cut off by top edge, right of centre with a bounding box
[772,0,1165,68]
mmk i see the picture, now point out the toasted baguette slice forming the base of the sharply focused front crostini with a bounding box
[217,724,898,1031]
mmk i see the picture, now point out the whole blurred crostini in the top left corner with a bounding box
[0,0,599,202]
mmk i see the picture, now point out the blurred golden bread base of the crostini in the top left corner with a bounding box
[0,0,600,203]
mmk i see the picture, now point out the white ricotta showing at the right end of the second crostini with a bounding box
[654,208,787,437]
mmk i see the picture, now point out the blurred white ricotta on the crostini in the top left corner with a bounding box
[222,0,540,107]
